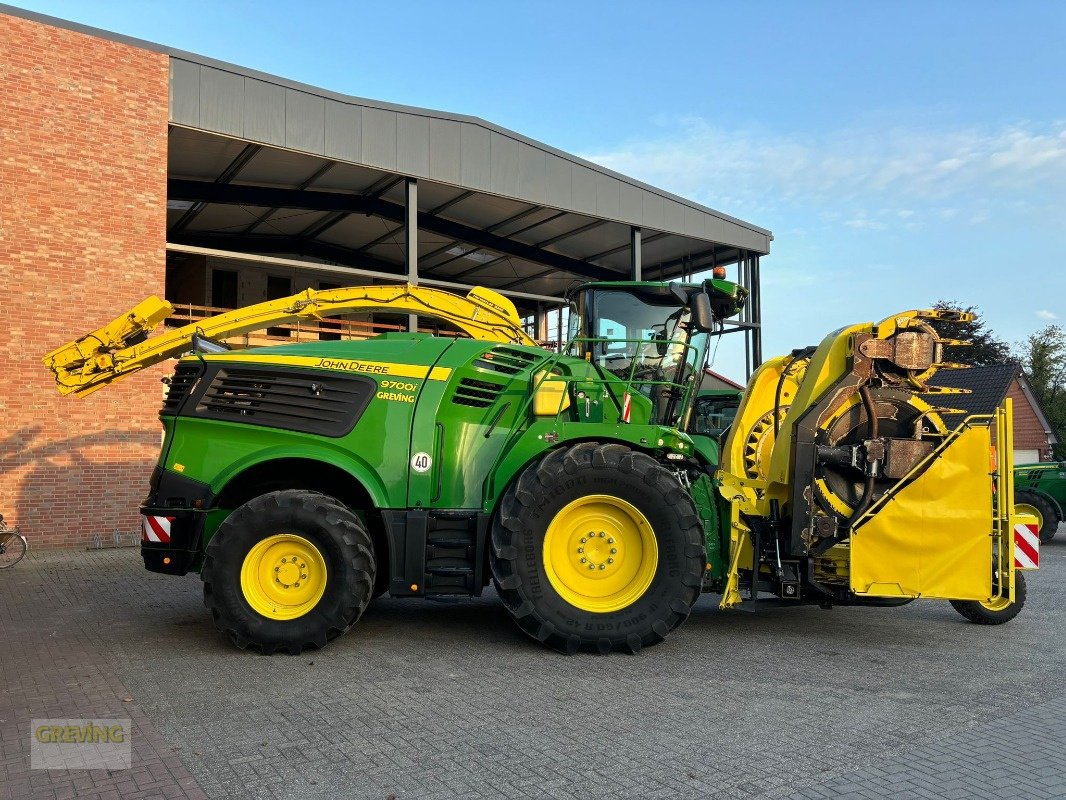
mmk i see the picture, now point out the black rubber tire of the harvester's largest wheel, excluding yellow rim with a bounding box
[489,442,706,654]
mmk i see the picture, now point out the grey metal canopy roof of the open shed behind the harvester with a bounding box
[0,5,773,368]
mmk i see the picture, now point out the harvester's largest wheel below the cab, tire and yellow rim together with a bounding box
[490,443,705,654]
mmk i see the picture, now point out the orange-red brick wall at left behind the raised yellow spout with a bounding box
[0,14,168,547]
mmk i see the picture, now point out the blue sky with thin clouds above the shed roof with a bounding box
[10,0,1066,379]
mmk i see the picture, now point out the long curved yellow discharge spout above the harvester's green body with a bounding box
[43,286,536,396]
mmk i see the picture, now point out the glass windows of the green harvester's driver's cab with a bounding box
[576,289,708,425]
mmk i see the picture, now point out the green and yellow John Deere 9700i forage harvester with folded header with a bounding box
[45,279,1033,653]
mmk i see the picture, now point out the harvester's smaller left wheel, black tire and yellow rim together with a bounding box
[200,491,375,655]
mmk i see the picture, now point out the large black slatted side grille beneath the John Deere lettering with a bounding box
[195,367,376,436]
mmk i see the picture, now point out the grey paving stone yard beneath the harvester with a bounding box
[0,529,1066,800]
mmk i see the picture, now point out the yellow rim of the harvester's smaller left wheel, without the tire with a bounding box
[241,533,327,620]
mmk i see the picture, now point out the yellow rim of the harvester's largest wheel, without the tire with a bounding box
[544,495,659,613]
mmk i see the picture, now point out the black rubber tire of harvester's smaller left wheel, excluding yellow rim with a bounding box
[200,490,376,655]
